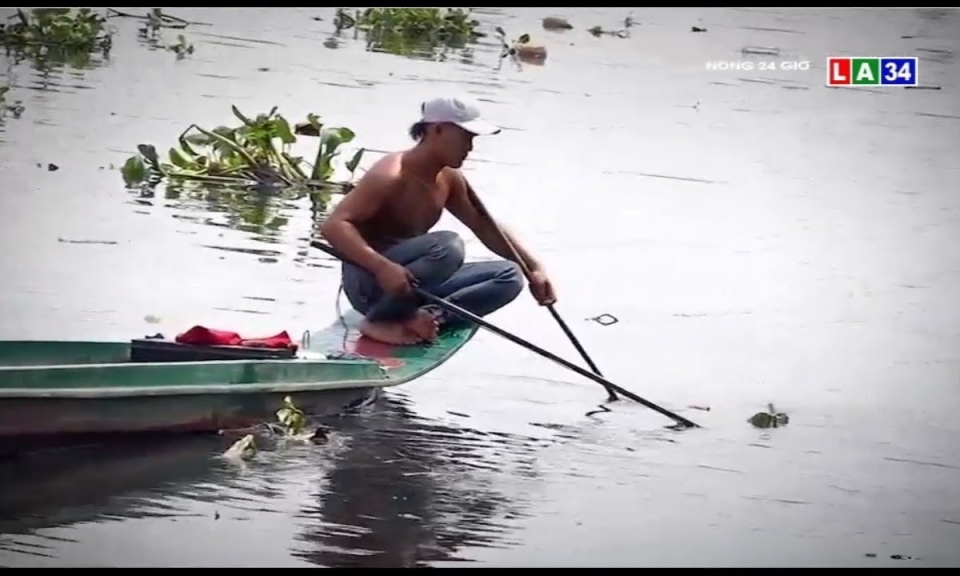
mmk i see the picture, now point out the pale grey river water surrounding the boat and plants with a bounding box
[0,8,960,566]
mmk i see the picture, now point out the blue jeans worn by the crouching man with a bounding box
[343,231,523,326]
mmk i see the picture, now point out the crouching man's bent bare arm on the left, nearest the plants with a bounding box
[320,167,392,275]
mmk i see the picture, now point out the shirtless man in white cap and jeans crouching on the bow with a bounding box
[320,97,556,345]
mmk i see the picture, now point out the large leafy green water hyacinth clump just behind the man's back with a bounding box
[121,106,364,187]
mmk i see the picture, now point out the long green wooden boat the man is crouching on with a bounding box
[0,310,477,447]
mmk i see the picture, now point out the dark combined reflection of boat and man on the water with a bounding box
[0,395,545,567]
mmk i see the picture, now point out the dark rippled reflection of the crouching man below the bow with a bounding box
[295,397,543,567]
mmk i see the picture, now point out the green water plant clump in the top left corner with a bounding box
[0,8,113,52]
